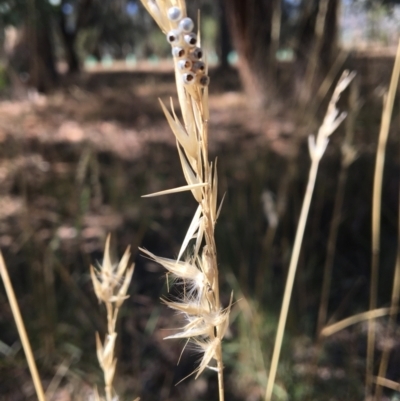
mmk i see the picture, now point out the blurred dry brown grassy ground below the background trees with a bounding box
[0,47,400,401]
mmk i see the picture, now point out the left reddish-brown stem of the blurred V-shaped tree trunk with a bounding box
[224,0,280,108]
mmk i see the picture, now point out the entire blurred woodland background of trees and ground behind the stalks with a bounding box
[0,0,400,401]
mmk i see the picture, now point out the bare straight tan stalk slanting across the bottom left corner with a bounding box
[0,252,46,401]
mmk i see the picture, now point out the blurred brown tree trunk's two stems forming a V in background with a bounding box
[224,0,340,108]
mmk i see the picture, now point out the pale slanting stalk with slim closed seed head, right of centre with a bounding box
[265,71,354,401]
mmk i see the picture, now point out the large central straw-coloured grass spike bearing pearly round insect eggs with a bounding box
[141,0,232,401]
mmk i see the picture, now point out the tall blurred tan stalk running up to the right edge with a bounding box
[365,41,400,398]
